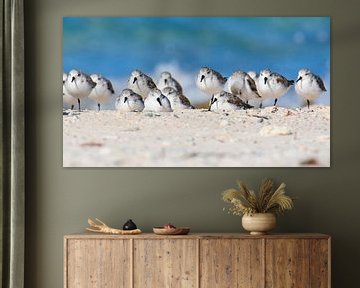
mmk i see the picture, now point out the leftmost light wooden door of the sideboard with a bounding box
[65,239,132,288]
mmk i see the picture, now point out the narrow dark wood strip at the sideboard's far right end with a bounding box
[310,239,330,288]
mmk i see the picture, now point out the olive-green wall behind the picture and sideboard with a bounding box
[25,0,360,288]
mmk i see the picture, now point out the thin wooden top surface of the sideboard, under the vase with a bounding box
[64,232,330,239]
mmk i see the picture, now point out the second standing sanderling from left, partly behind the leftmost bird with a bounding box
[89,74,115,111]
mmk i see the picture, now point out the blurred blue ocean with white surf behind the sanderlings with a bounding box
[63,17,330,109]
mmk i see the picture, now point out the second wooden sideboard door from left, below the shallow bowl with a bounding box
[134,239,198,288]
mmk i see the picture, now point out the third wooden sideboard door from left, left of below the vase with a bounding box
[200,239,264,288]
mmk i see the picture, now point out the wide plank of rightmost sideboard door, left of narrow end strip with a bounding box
[265,239,310,288]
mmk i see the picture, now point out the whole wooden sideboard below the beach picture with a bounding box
[64,234,331,288]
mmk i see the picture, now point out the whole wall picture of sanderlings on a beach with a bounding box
[62,17,330,167]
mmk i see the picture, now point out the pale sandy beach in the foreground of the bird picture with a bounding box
[63,106,330,167]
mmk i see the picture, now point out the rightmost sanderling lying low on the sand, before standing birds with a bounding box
[209,91,253,111]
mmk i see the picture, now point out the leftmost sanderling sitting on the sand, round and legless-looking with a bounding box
[115,89,145,112]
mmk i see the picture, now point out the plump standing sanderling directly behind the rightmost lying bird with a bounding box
[227,71,261,103]
